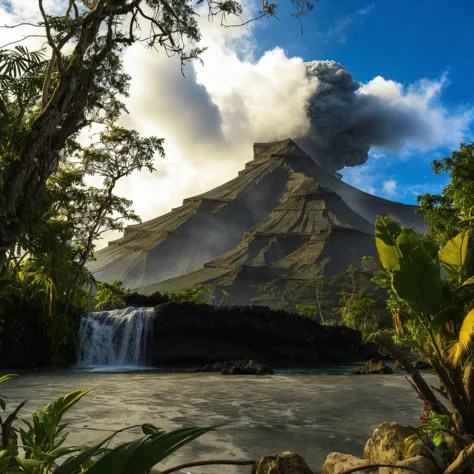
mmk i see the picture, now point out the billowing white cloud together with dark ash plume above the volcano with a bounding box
[0,0,473,245]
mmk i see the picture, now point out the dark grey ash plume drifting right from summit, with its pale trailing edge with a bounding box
[306,61,473,171]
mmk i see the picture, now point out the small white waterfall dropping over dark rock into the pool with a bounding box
[77,308,153,368]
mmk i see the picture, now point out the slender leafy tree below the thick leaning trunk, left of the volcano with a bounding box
[0,126,163,362]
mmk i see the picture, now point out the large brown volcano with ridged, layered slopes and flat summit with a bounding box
[89,139,426,304]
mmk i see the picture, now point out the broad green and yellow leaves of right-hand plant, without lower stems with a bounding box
[376,217,474,363]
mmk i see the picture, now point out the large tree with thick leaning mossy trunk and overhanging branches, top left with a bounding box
[0,0,314,270]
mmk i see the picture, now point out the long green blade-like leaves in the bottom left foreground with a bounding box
[0,375,217,474]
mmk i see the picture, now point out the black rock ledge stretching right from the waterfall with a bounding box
[148,302,361,367]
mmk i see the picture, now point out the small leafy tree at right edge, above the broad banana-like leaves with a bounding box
[418,143,474,245]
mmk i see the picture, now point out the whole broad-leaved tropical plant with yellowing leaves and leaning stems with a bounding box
[375,216,474,474]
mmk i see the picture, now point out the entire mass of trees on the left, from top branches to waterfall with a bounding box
[0,0,317,363]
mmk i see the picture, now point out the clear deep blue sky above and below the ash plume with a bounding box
[250,0,474,203]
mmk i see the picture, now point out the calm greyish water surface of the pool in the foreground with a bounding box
[0,367,435,473]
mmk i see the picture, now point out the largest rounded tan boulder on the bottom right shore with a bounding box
[364,422,431,464]
